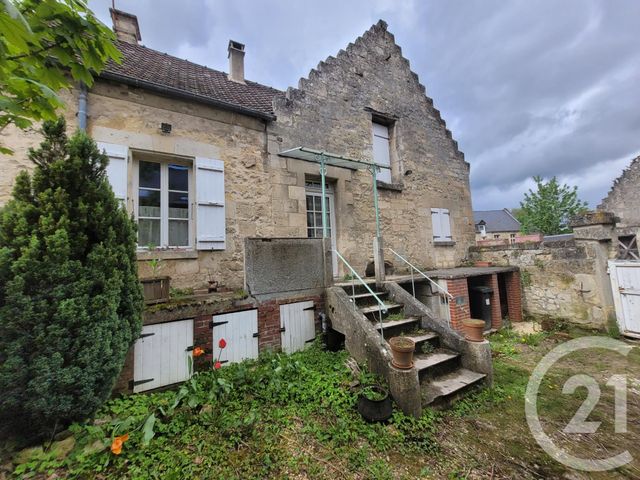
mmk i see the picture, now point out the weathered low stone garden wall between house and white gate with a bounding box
[471,239,613,328]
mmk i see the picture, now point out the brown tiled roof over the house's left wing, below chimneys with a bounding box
[101,42,283,116]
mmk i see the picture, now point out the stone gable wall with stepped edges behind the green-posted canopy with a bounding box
[269,22,475,273]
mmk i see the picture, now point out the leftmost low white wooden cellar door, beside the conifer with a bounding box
[133,319,193,393]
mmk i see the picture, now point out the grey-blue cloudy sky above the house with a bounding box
[89,0,640,210]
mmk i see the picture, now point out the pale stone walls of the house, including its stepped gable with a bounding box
[0,22,474,288]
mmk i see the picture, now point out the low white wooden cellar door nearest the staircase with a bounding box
[280,301,316,353]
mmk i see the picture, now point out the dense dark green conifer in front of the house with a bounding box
[0,119,142,436]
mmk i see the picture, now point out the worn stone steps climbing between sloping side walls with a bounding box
[336,283,487,408]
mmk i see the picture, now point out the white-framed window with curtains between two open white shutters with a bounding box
[136,160,192,247]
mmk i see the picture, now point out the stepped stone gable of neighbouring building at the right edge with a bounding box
[598,157,640,228]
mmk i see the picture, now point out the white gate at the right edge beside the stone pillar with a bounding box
[609,260,640,336]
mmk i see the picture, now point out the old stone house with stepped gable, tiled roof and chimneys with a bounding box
[0,9,521,412]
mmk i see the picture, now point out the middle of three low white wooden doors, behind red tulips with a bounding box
[213,310,258,365]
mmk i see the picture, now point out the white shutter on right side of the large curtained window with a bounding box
[195,157,226,250]
